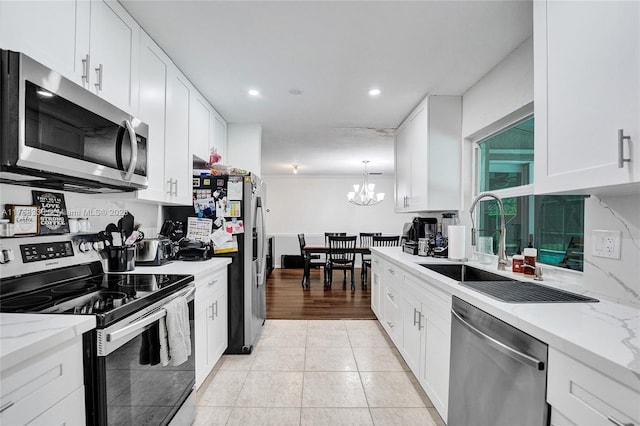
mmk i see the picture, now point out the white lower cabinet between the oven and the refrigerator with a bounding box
[195,267,228,389]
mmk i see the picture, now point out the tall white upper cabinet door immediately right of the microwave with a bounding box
[138,32,171,202]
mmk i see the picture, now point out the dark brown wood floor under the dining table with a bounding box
[267,268,376,320]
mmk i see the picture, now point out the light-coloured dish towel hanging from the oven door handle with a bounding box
[159,296,191,366]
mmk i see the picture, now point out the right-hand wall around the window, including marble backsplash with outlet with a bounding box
[460,35,640,306]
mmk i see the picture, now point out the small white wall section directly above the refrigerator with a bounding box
[228,123,262,176]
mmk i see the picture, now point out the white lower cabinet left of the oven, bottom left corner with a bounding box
[0,336,85,425]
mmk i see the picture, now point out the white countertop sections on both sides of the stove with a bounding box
[0,257,232,370]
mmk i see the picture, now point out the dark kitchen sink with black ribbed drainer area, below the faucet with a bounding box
[420,263,598,303]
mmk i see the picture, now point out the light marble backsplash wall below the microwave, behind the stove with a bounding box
[0,184,161,237]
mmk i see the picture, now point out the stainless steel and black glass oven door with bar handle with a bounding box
[87,287,195,426]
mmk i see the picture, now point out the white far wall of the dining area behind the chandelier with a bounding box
[263,175,416,267]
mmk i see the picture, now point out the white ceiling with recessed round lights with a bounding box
[120,0,532,175]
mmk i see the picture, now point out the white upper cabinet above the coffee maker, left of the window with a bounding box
[395,96,462,212]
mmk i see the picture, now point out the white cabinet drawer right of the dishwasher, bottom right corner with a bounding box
[547,348,640,426]
